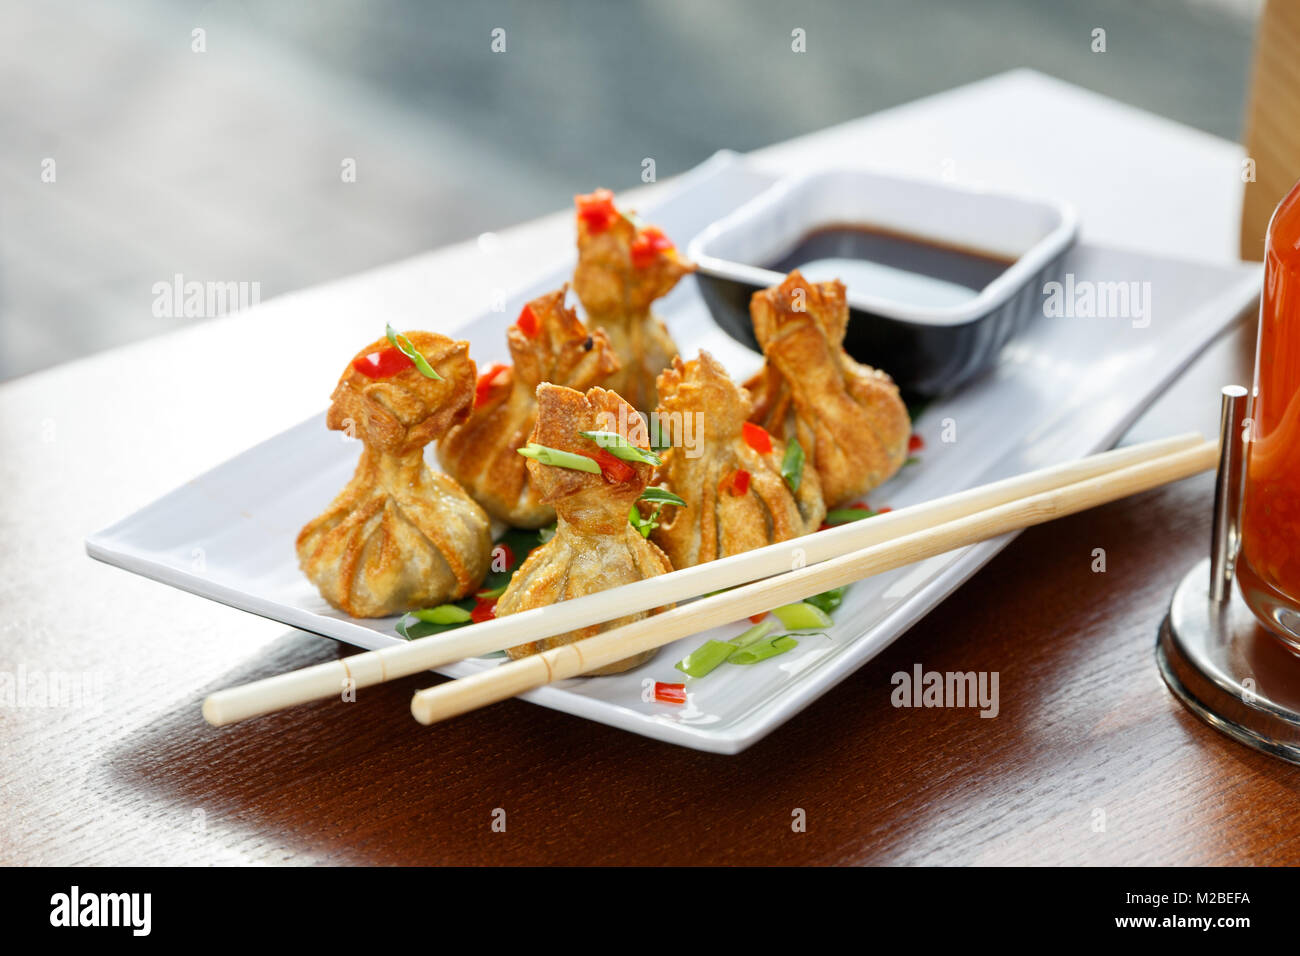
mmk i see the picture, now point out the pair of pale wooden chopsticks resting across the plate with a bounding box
[203,434,1218,726]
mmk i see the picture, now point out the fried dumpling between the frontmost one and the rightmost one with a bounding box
[651,351,826,568]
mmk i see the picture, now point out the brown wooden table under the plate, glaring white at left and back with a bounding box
[0,73,1300,864]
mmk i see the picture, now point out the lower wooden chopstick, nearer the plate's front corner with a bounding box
[411,441,1218,724]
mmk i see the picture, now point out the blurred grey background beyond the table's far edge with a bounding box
[0,0,1258,380]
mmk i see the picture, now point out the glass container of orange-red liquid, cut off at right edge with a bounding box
[1236,183,1300,653]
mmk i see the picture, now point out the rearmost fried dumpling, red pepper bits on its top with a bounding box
[573,189,696,412]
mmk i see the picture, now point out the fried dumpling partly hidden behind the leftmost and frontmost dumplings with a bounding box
[438,286,619,528]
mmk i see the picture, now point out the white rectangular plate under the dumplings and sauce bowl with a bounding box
[86,153,1258,753]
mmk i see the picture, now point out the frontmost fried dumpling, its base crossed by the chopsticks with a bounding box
[497,385,672,674]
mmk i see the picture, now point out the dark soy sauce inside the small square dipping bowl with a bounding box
[767,222,1015,307]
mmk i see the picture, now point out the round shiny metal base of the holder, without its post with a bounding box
[1156,558,1300,763]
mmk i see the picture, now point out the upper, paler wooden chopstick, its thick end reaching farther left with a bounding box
[203,434,1204,726]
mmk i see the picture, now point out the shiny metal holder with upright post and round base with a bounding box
[1156,385,1300,763]
